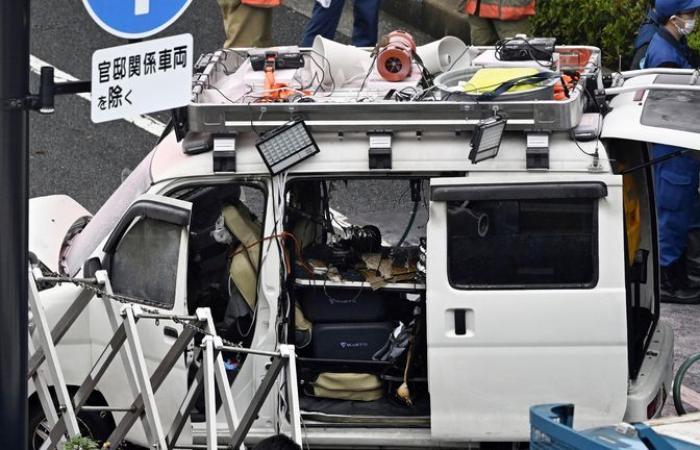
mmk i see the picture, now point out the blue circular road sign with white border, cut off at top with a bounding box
[83,0,192,39]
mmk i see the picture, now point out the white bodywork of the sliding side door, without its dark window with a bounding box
[427,174,628,441]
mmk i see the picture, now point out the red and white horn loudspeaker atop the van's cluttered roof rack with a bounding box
[377,30,416,81]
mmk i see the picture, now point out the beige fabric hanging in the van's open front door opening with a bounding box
[222,202,262,309]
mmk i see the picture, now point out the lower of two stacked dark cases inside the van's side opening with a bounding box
[312,322,397,361]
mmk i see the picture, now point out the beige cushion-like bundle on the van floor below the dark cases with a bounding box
[313,372,384,402]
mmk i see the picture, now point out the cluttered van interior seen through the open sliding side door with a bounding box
[284,178,430,426]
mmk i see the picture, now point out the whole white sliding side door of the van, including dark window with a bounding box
[427,173,628,441]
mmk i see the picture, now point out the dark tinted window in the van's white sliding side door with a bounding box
[447,198,598,289]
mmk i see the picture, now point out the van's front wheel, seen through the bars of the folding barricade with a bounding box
[27,402,115,450]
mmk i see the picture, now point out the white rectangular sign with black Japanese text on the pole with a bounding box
[91,34,193,123]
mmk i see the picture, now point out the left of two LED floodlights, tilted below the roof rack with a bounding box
[255,121,320,175]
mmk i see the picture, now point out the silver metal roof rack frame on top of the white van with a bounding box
[187,46,601,134]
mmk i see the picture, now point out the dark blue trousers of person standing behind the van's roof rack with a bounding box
[301,0,381,47]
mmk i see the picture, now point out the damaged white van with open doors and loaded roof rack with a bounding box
[29,43,700,448]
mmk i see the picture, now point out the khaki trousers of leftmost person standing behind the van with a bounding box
[218,0,274,48]
